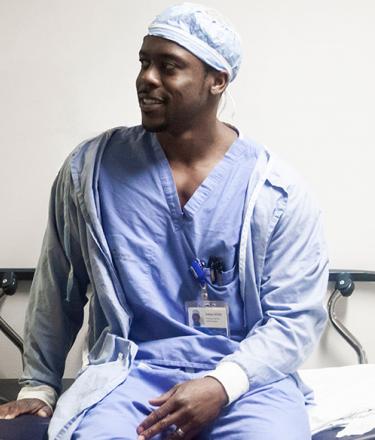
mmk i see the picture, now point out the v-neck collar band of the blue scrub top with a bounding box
[151,133,245,229]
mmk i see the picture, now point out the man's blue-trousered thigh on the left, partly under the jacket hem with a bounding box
[72,364,184,440]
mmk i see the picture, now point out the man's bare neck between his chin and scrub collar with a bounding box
[157,119,237,167]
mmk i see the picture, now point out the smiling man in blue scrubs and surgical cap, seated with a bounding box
[0,3,327,440]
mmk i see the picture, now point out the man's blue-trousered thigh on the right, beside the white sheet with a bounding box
[199,378,311,440]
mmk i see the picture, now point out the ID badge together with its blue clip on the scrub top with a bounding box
[185,258,230,337]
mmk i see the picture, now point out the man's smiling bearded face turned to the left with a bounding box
[136,36,212,133]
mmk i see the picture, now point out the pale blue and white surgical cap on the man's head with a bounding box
[148,3,241,81]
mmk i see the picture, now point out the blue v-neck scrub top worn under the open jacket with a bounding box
[99,130,257,369]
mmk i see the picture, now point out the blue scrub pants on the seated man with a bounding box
[72,363,311,440]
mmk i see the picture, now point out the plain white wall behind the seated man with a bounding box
[0,0,375,375]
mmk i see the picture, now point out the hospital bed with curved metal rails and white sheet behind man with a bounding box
[0,269,375,440]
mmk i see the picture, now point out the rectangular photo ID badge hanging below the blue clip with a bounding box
[185,300,229,337]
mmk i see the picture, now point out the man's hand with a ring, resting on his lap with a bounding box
[137,377,228,440]
